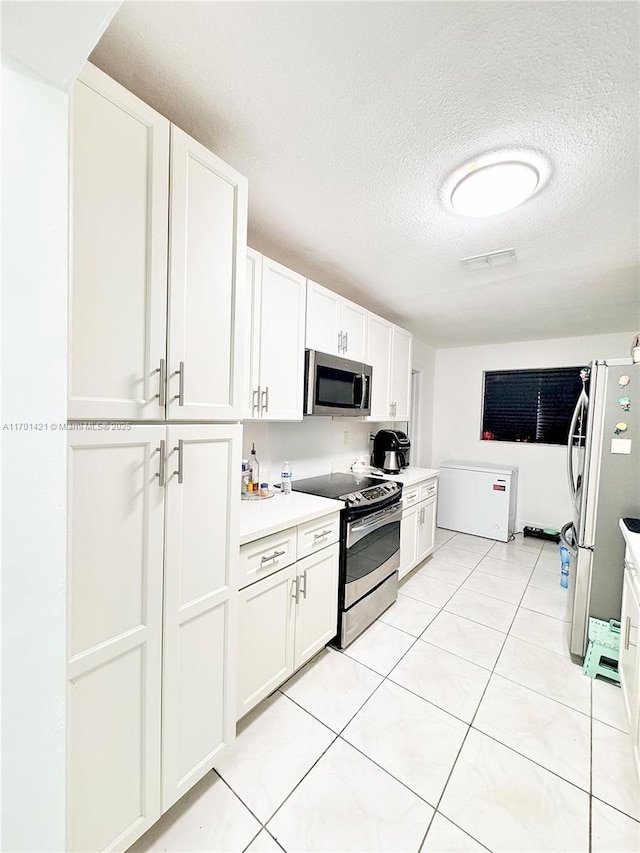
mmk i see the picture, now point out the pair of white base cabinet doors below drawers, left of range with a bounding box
[237,514,339,719]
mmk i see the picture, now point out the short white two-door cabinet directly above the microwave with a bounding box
[305,280,369,361]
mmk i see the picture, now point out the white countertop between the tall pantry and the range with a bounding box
[240,489,344,545]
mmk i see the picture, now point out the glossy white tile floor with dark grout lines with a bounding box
[132,530,640,853]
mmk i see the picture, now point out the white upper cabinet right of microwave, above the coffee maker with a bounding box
[365,313,413,421]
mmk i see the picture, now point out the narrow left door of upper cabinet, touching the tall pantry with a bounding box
[242,249,262,420]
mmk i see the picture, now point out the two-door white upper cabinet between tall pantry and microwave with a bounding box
[243,249,306,421]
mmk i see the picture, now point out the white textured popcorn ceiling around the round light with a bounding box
[91,0,640,346]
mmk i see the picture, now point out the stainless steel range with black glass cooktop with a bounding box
[293,474,402,649]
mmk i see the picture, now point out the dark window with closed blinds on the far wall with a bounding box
[481,367,582,444]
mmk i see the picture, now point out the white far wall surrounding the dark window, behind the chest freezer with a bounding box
[432,332,633,530]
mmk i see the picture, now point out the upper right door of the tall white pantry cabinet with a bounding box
[168,125,247,420]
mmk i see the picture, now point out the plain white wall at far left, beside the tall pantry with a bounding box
[1,61,68,851]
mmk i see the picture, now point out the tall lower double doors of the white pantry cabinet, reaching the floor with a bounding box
[67,425,241,853]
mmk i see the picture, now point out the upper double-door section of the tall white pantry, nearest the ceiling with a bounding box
[69,65,247,420]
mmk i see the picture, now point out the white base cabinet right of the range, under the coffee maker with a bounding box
[398,478,437,578]
